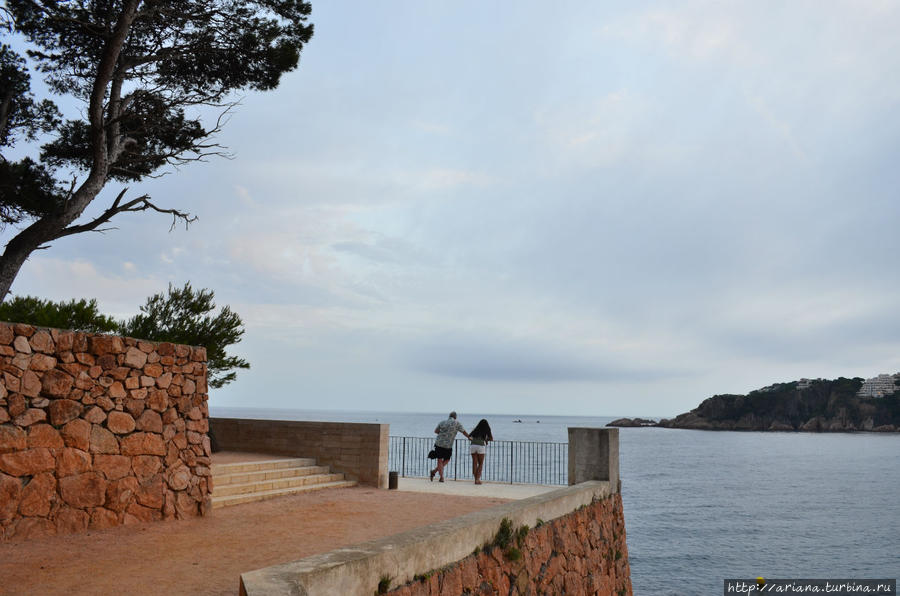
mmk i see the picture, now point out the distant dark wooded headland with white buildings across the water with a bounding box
[607,373,900,432]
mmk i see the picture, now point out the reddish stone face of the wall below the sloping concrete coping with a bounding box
[387,494,632,596]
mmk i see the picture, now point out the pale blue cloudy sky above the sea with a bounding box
[2,0,900,417]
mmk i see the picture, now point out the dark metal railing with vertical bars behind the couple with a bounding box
[388,437,569,485]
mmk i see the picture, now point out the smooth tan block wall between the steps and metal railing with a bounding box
[210,418,390,488]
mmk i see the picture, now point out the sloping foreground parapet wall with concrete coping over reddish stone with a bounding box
[241,481,631,596]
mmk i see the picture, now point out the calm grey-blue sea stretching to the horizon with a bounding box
[211,406,900,596]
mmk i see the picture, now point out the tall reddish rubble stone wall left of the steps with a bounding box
[0,323,212,540]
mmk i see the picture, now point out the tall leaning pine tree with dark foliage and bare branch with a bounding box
[0,0,313,300]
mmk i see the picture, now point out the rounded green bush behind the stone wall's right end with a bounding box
[121,282,250,389]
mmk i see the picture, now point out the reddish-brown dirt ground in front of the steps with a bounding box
[0,487,505,596]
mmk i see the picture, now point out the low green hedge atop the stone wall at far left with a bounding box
[0,296,119,333]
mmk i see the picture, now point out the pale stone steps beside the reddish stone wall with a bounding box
[212,458,356,509]
